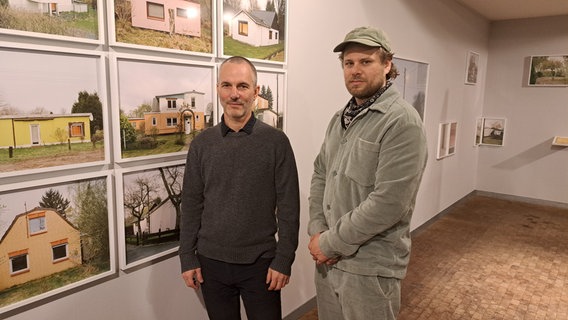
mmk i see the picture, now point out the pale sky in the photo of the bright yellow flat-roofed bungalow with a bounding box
[0,49,99,114]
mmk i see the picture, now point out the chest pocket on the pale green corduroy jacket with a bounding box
[345,138,381,187]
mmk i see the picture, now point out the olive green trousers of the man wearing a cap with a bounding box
[315,265,401,320]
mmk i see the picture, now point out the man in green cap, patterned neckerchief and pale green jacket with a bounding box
[308,27,427,320]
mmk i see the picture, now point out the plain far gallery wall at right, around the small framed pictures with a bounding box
[477,16,568,203]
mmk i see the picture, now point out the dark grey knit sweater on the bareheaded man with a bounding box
[179,121,300,275]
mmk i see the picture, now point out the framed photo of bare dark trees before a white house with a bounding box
[116,161,185,270]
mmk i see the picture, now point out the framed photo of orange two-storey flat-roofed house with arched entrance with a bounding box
[110,54,214,162]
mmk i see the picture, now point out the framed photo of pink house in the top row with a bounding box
[107,0,216,56]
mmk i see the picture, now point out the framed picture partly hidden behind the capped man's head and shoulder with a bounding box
[393,57,428,121]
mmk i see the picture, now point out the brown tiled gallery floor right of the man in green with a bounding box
[300,196,568,320]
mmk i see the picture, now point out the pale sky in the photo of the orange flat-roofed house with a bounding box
[118,59,213,114]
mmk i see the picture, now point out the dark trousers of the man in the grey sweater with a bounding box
[199,256,282,320]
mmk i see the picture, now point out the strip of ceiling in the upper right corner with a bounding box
[456,0,568,21]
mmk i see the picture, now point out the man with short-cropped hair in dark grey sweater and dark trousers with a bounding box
[179,57,300,320]
